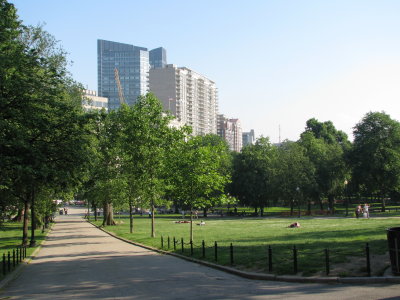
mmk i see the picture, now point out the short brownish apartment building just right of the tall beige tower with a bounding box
[217,115,242,152]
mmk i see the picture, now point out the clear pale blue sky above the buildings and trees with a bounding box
[10,0,400,142]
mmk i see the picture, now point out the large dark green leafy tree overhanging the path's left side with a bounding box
[0,0,87,245]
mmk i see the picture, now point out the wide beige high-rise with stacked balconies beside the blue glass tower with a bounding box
[150,65,218,135]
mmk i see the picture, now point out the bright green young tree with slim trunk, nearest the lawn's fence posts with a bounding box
[169,135,230,241]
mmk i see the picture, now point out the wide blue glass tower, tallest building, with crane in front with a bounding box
[97,40,150,110]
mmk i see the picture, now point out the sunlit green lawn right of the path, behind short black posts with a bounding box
[92,215,400,275]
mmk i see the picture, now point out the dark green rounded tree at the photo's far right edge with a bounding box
[350,112,400,211]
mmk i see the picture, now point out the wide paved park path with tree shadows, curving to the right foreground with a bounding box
[0,209,400,300]
